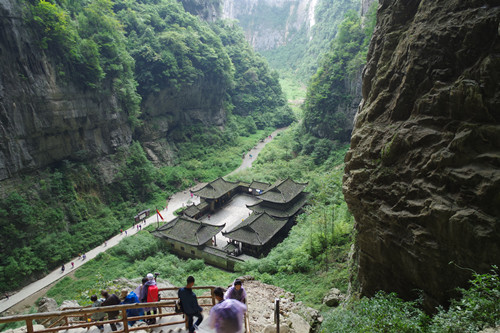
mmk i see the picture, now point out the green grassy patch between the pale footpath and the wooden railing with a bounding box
[47,231,237,305]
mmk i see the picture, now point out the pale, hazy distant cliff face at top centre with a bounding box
[223,0,318,51]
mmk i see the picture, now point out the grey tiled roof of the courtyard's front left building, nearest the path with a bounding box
[155,216,225,246]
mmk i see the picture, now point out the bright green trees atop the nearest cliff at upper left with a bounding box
[25,0,141,126]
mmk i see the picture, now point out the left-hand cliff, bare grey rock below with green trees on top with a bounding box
[0,0,232,180]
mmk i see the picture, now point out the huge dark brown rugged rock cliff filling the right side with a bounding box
[344,0,500,309]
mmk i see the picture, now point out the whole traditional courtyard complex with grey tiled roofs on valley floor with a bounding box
[154,178,308,270]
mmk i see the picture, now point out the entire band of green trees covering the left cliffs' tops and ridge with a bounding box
[25,0,293,129]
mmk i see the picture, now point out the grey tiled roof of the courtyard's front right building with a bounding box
[222,213,288,245]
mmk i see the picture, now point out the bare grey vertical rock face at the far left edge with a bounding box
[0,0,132,180]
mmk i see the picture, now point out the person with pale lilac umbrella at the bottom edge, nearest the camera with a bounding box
[209,287,247,333]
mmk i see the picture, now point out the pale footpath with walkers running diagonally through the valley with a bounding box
[0,127,286,313]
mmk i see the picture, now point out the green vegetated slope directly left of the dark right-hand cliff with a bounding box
[304,3,376,142]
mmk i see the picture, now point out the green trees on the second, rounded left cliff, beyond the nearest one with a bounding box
[114,0,232,96]
